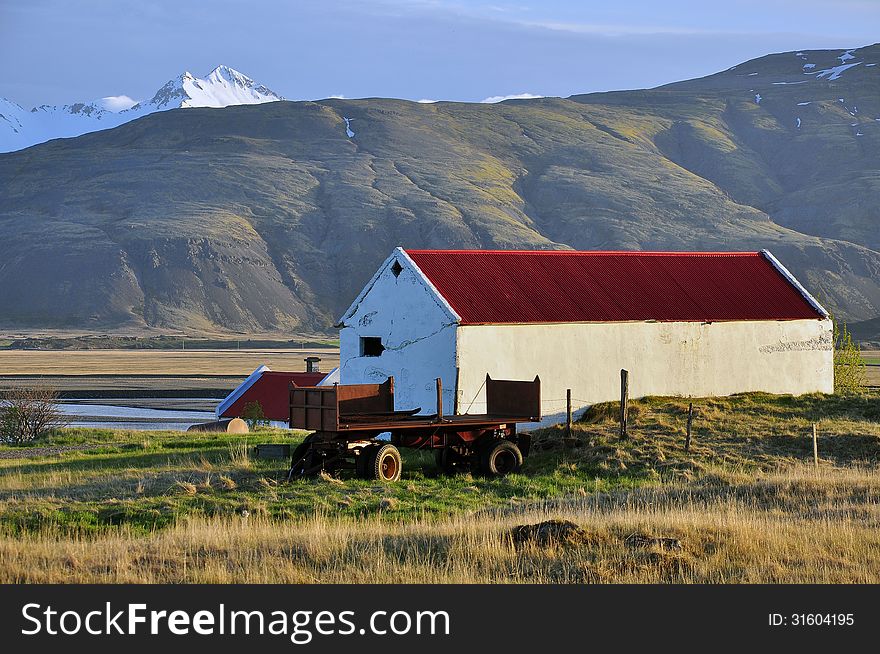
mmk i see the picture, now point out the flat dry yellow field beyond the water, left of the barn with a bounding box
[0,348,339,376]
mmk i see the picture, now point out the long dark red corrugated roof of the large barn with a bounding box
[406,250,823,324]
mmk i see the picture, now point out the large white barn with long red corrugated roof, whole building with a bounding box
[337,248,834,423]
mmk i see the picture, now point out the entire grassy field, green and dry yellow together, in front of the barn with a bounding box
[0,393,880,583]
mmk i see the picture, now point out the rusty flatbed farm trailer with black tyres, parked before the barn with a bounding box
[288,375,541,481]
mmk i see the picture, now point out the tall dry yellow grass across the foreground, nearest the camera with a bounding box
[0,467,880,583]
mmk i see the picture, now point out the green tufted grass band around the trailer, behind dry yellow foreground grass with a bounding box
[0,394,880,534]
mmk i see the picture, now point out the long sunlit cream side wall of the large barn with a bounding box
[457,319,834,424]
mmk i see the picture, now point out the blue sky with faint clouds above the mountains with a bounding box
[0,0,880,108]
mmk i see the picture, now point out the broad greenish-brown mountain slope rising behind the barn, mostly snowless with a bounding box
[0,45,880,331]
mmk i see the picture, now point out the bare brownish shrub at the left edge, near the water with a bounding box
[0,386,67,443]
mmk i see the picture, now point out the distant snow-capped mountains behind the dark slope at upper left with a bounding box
[0,66,284,152]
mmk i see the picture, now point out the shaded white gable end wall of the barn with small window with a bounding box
[339,255,457,414]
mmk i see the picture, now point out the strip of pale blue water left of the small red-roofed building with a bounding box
[56,399,216,431]
